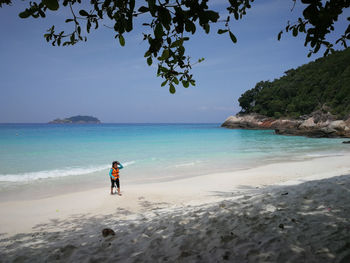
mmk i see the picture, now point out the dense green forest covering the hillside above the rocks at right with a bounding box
[238,48,350,118]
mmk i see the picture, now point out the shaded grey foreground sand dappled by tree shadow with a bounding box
[0,175,350,263]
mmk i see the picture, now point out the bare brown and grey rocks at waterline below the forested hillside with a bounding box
[221,110,350,138]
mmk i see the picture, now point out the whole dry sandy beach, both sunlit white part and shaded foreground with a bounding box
[0,155,350,262]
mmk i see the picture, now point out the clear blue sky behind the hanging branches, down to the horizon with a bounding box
[0,0,350,123]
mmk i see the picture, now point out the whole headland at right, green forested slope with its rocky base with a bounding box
[222,48,350,138]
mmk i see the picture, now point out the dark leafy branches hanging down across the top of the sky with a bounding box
[0,0,350,93]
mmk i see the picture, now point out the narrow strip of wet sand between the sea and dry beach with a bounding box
[0,151,350,204]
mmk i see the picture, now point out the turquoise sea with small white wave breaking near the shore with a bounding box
[0,124,349,195]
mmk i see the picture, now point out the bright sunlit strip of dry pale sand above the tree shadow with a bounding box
[0,155,350,236]
